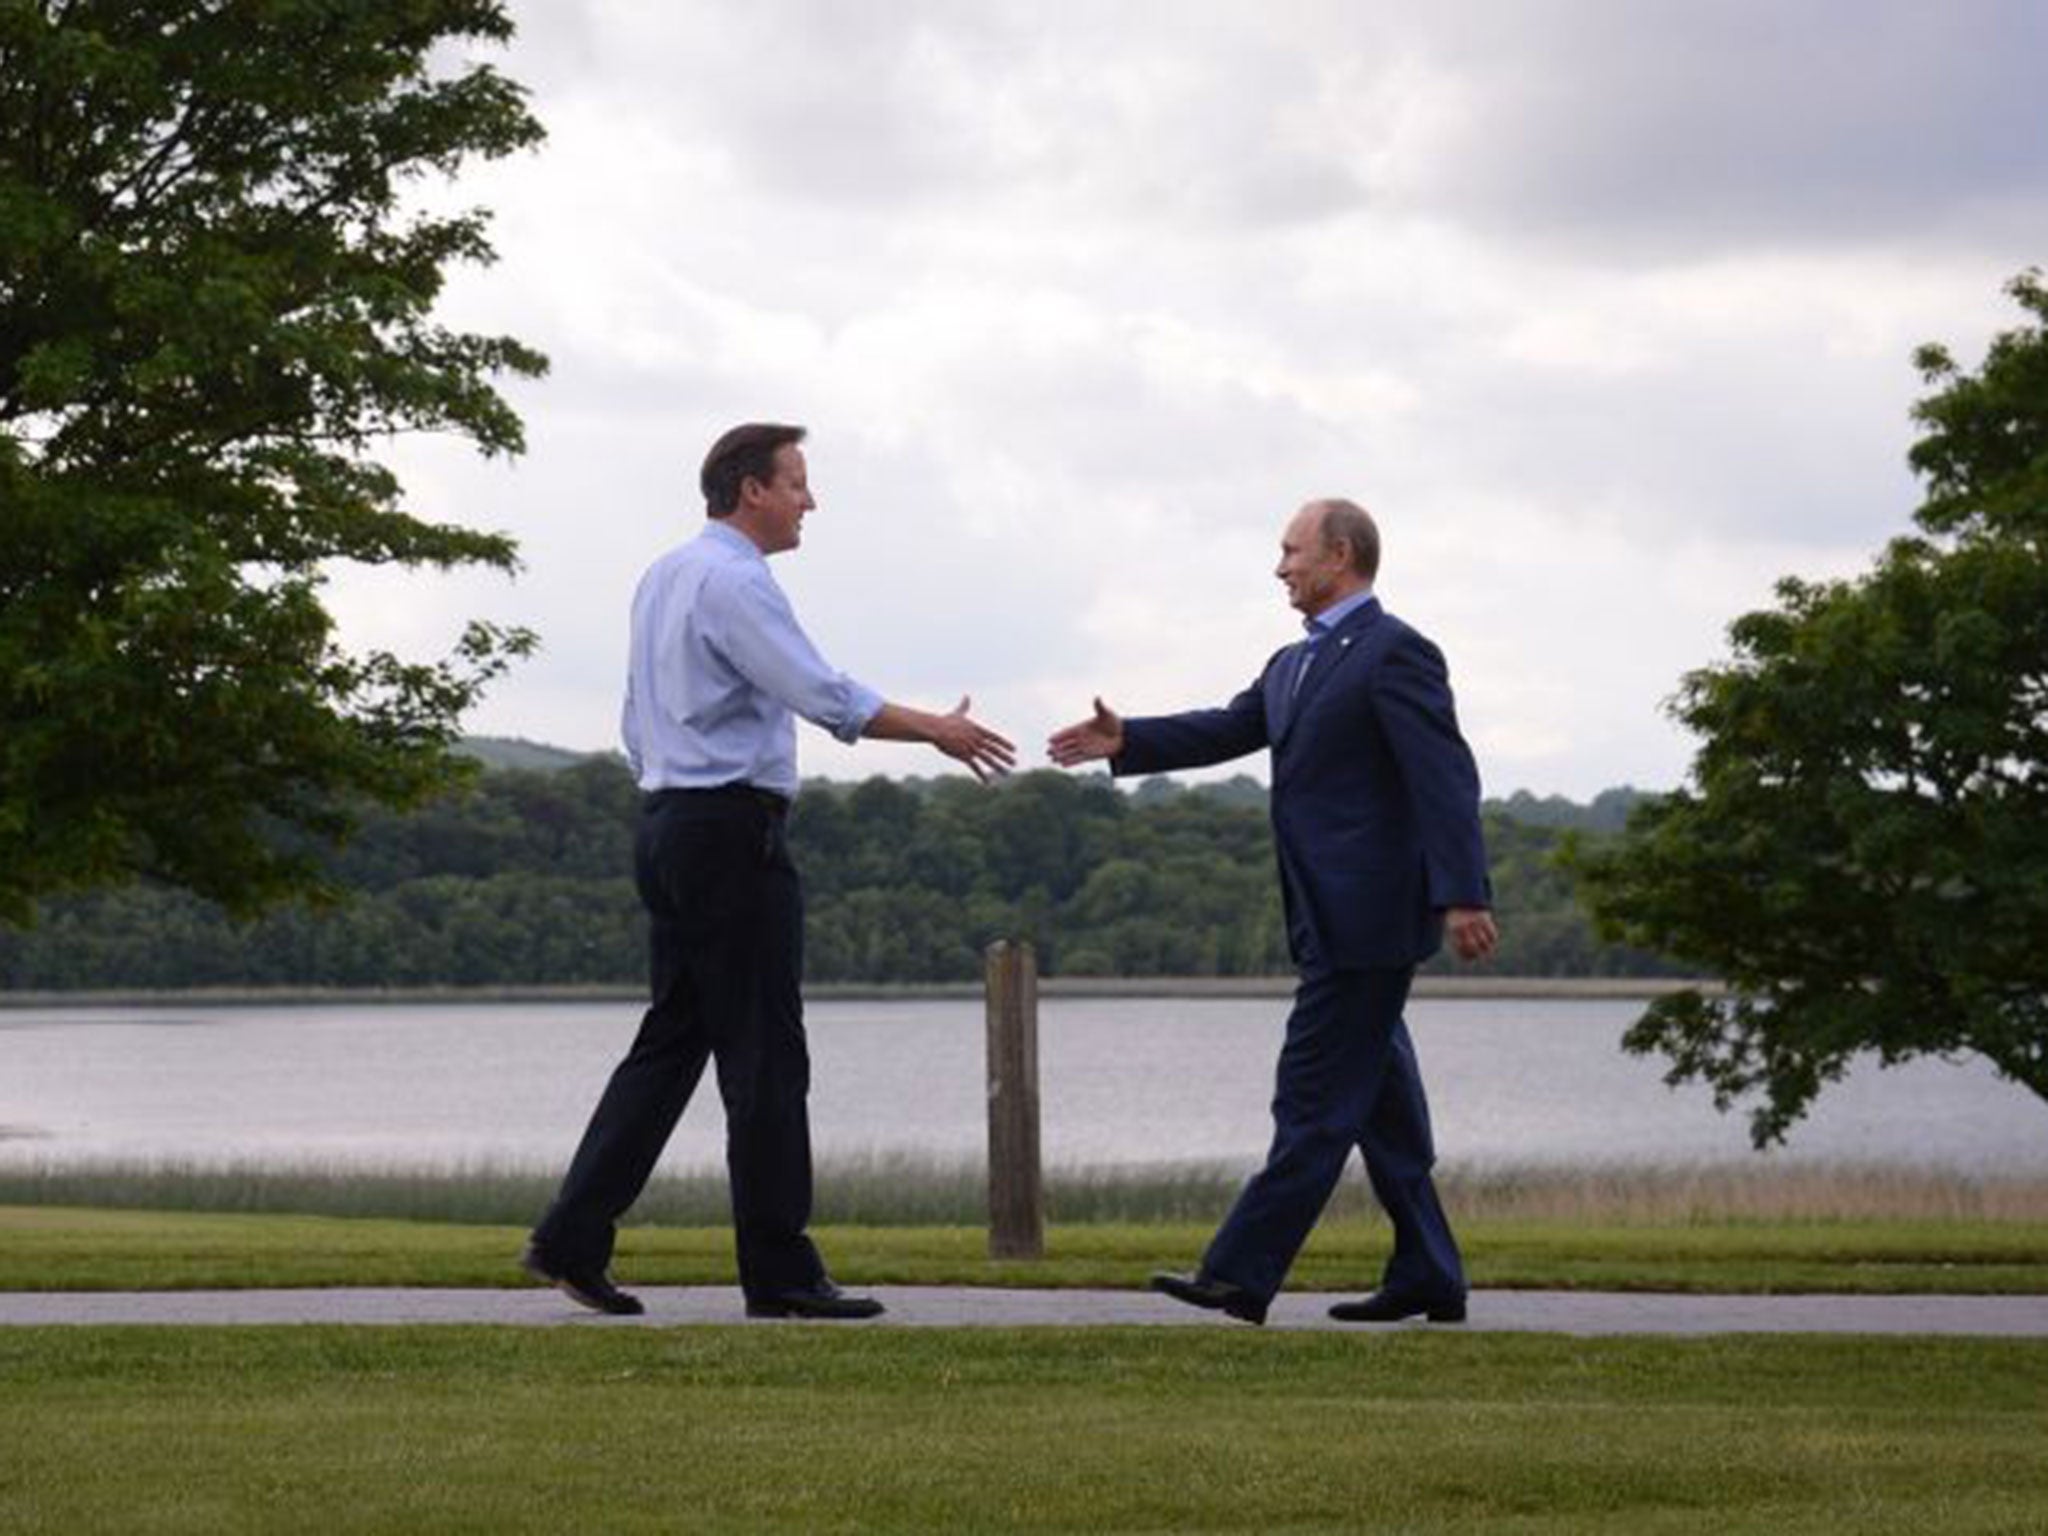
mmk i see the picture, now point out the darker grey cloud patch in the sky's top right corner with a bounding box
[1405,0,2048,256]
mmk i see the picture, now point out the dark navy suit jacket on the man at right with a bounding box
[1110,600,1493,971]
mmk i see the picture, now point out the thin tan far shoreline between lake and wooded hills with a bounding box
[0,975,1720,1010]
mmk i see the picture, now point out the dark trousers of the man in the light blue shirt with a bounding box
[532,786,825,1296]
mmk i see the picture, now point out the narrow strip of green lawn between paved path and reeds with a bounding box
[12,1206,2048,1294]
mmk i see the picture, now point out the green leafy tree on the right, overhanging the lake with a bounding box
[1577,270,2048,1147]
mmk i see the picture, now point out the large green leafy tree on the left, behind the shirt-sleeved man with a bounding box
[0,0,545,922]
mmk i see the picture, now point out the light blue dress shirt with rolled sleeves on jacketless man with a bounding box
[621,522,883,797]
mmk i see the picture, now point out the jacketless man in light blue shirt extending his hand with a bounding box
[524,424,1016,1317]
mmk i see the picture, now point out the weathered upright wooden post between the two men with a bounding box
[987,938,1044,1260]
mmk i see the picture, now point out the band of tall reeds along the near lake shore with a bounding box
[0,1153,2048,1227]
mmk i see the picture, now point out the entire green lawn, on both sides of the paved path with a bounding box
[16,1206,2048,1536]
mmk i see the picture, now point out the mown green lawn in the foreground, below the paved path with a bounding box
[0,1327,2048,1536]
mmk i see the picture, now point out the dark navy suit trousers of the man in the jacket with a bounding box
[1202,969,1464,1298]
